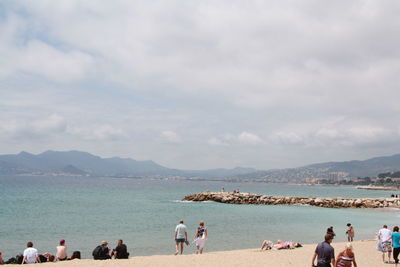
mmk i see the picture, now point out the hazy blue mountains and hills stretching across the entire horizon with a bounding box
[0,151,400,181]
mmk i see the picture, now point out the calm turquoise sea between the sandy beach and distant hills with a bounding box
[0,176,399,258]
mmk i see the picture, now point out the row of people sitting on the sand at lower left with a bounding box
[0,239,129,265]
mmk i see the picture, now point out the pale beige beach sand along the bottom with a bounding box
[42,240,382,267]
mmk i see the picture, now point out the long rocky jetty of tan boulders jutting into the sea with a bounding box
[182,192,400,208]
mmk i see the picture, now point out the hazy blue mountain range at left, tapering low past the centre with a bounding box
[0,151,257,178]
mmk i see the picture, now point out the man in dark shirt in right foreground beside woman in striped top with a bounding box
[311,234,335,267]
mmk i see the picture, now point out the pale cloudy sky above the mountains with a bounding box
[0,0,400,169]
